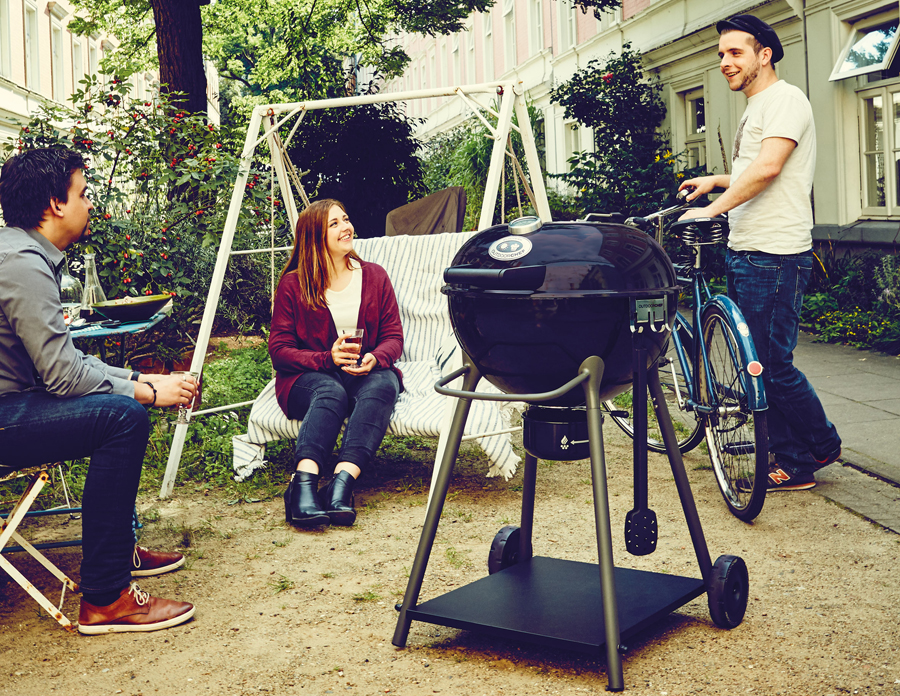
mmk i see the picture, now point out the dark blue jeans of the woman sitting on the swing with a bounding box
[288,370,400,473]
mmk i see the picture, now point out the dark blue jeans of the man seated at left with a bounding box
[0,390,150,593]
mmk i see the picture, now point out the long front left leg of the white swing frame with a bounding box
[159,108,262,498]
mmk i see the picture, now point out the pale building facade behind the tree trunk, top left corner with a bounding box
[0,0,219,145]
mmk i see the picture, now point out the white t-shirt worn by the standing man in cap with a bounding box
[728,80,816,254]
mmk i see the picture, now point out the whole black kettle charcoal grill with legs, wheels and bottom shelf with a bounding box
[393,218,747,691]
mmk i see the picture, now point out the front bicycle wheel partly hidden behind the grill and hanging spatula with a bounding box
[604,340,705,454]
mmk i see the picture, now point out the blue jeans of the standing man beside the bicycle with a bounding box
[726,249,841,474]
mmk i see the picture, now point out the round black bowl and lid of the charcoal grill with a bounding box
[443,218,678,405]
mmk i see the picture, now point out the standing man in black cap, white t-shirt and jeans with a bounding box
[681,15,841,491]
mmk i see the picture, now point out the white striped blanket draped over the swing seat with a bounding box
[233,233,519,480]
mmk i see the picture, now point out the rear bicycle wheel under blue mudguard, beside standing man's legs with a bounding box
[697,305,769,522]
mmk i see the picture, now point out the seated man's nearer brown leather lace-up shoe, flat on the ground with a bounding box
[78,582,194,636]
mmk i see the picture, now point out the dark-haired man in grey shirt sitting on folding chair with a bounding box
[0,149,195,634]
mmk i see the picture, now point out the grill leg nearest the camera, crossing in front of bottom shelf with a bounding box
[579,356,625,691]
